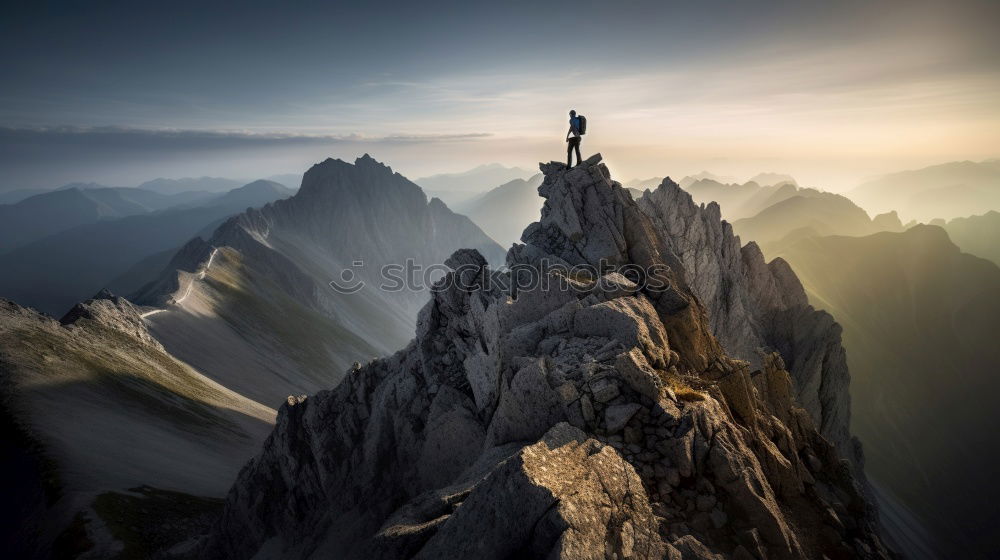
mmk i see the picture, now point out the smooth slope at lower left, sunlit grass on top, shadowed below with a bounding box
[0,306,274,495]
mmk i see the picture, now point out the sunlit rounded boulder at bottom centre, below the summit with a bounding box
[406,424,664,560]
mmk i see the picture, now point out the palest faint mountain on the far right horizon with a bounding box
[847,160,1000,222]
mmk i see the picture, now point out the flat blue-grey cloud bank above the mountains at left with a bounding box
[0,126,491,190]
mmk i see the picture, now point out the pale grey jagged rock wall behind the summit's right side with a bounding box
[638,178,862,464]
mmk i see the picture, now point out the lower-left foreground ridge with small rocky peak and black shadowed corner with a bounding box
[0,291,275,558]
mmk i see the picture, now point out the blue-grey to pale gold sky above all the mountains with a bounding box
[0,0,1000,191]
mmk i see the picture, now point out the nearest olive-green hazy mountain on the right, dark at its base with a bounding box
[773,225,1000,558]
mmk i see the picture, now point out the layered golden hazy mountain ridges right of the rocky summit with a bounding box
[676,165,1000,558]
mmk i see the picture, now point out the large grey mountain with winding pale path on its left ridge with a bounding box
[133,155,504,406]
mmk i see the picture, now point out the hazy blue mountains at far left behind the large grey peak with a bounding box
[0,181,293,317]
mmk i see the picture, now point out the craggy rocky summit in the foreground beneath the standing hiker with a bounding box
[197,156,889,559]
